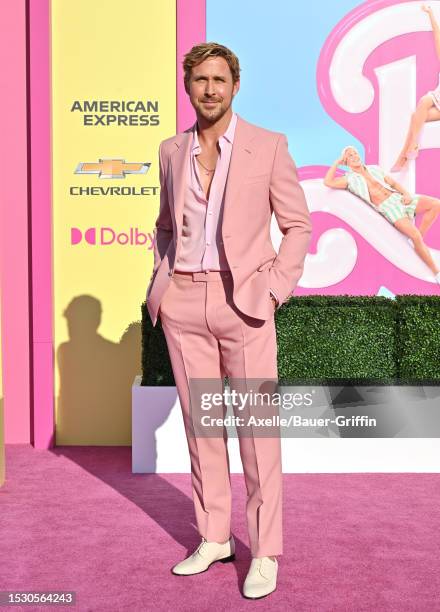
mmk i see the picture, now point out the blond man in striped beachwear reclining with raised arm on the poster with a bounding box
[324,146,440,284]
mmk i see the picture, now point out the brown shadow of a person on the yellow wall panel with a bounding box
[56,295,141,446]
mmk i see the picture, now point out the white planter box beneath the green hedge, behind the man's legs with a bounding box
[132,376,440,474]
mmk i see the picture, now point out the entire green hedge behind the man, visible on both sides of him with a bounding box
[142,296,440,386]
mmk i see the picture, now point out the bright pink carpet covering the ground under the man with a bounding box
[0,445,440,612]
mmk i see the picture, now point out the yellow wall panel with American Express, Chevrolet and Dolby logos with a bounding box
[51,0,176,445]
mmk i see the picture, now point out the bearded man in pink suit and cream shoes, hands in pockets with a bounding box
[147,43,311,598]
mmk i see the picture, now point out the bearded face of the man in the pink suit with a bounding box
[187,57,240,123]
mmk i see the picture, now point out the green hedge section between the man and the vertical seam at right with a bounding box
[276,296,397,384]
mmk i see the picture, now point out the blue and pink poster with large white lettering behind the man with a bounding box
[207,0,440,296]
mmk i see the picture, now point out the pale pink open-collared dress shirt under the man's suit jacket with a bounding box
[175,113,278,301]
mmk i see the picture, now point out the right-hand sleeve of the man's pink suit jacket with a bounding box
[269,134,312,305]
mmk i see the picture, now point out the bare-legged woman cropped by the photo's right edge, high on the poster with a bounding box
[391,5,440,172]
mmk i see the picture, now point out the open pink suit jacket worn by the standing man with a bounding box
[147,115,311,326]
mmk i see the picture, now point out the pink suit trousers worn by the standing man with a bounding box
[159,271,283,557]
